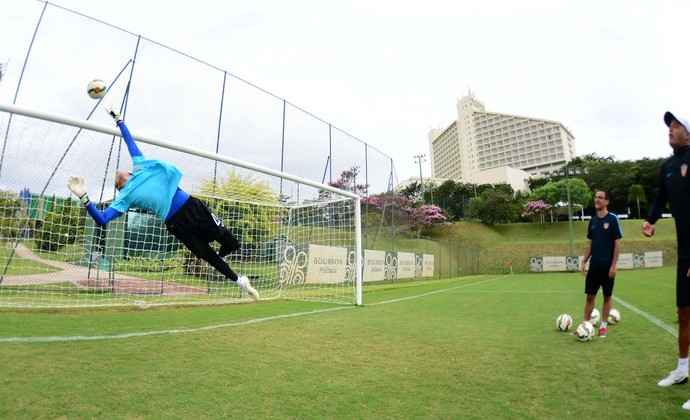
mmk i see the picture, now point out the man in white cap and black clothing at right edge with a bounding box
[642,112,690,410]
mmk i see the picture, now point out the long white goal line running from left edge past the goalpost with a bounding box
[0,276,507,343]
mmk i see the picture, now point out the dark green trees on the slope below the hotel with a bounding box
[399,154,664,224]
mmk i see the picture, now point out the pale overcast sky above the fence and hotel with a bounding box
[0,0,690,181]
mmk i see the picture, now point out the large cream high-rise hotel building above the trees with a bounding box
[429,94,575,190]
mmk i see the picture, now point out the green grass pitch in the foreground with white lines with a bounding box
[0,268,690,419]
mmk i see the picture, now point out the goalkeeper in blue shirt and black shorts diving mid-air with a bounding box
[67,109,259,300]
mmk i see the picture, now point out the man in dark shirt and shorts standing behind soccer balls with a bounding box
[580,190,623,338]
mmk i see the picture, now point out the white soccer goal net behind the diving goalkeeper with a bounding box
[0,103,362,307]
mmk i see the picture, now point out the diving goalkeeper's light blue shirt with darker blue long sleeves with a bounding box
[86,121,189,226]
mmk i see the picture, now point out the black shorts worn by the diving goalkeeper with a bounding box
[165,196,228,256]
